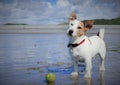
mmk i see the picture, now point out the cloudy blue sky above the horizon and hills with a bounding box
[0,0,120,25]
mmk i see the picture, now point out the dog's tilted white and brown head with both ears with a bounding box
[67,12,94,37]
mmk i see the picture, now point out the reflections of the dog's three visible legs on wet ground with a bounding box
[72,71,105,85]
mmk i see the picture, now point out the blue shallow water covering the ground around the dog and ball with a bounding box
[0,29,120,85]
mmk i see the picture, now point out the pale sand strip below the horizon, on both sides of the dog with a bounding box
[0,25,120,34]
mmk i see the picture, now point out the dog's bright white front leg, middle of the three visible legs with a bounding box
[84,57,92,78]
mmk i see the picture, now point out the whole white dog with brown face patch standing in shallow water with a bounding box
[67,12,106,78]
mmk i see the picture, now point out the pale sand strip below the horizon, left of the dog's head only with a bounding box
[0,25,67,34]
